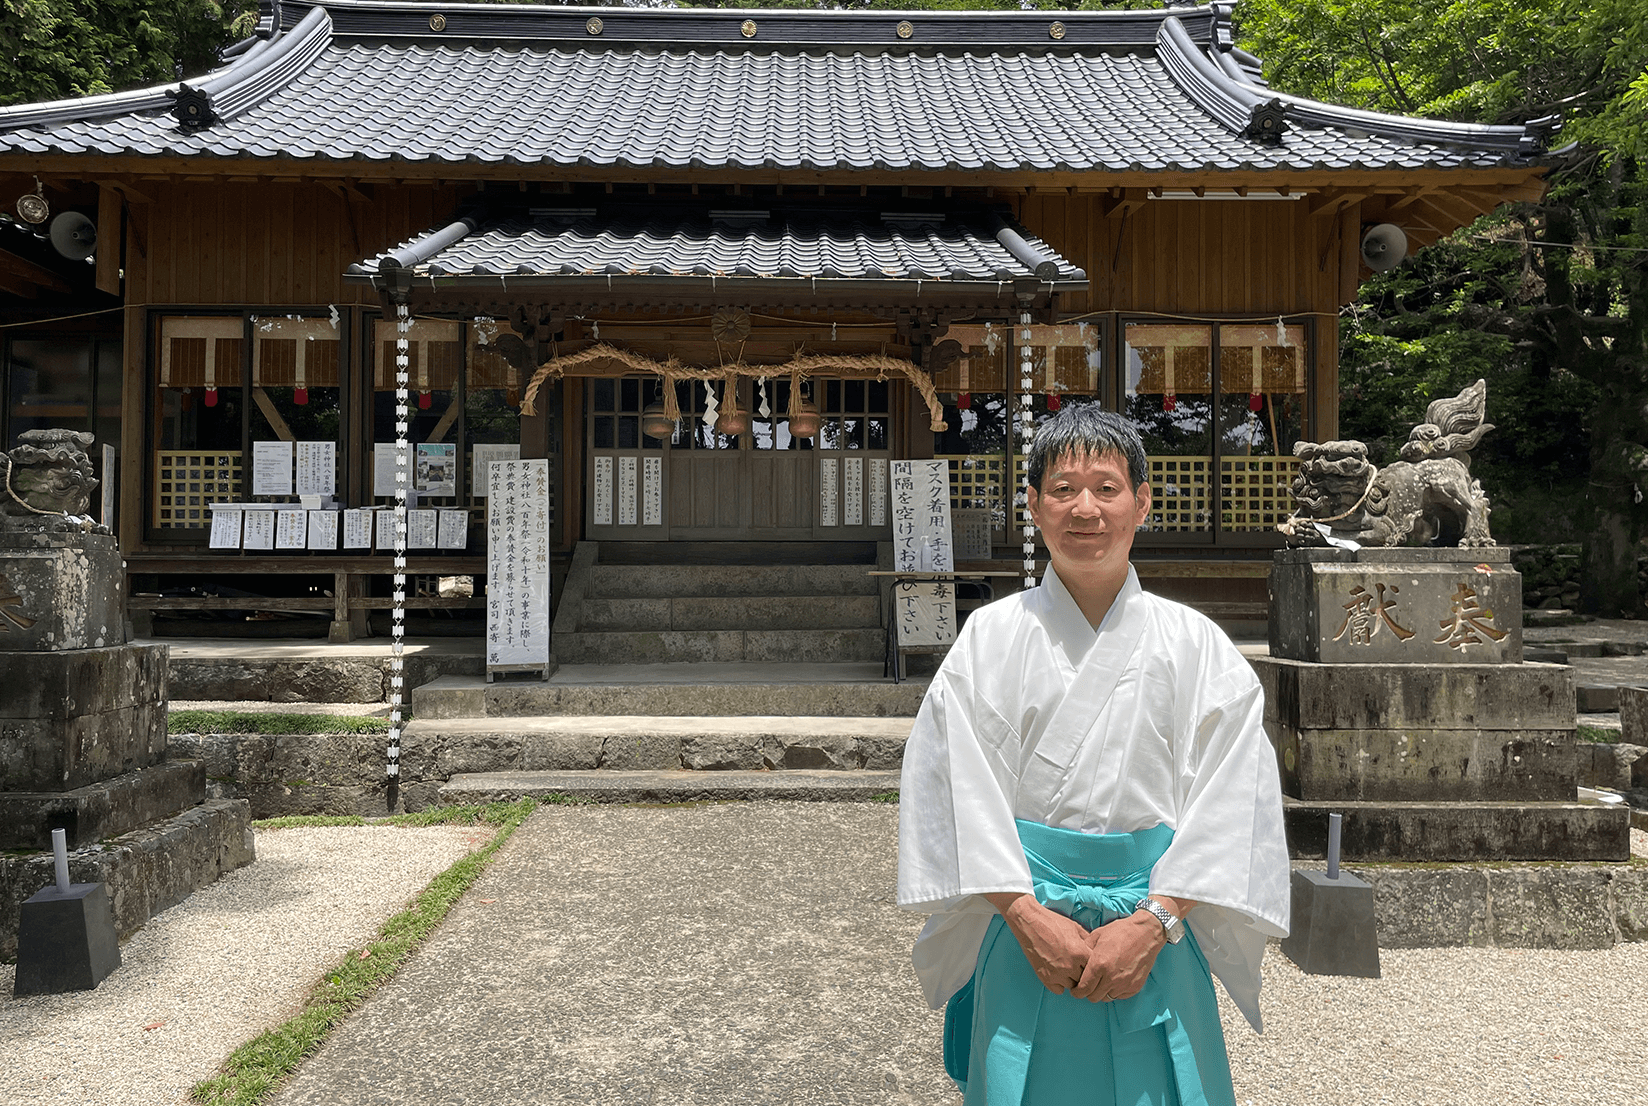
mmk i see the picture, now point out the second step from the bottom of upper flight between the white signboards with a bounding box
[578,595,882,633]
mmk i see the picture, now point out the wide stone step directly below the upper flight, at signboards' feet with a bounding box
[410,661,926,720]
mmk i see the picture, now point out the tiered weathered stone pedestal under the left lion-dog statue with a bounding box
[0,529,252,962]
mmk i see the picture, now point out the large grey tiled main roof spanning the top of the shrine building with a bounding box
[0,0,1541,171]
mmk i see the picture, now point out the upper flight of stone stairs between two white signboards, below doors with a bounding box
[555,542,885,664]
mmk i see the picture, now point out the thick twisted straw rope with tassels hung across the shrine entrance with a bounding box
[521,343,949,433]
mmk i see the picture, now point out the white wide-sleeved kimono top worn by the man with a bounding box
[898,567,1290,1030]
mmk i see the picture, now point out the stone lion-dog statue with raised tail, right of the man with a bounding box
[1277,381,1493,547]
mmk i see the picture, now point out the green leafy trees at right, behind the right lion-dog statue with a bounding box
[1239,0,1648,615]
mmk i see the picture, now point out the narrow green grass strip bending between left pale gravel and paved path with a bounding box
[190,799,537,1106]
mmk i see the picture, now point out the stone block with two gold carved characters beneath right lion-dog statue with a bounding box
[1271,549,1523,664]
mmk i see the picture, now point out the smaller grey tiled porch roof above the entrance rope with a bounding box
[349,208,1086,288]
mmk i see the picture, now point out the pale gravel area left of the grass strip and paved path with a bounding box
[0,826,494,1106]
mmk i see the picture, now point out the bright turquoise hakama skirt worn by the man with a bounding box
[944,821,1236,1106]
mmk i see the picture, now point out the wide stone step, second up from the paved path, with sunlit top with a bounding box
[400,715,911,778]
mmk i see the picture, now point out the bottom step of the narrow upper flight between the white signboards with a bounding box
[554,628,887,664]
